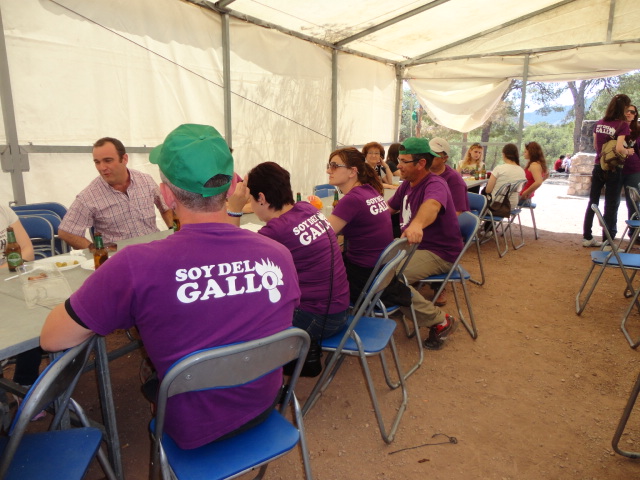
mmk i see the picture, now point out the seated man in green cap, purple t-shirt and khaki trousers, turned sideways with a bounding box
[389,137,463,350]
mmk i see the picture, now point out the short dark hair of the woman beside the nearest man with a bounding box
[247,162,294,210]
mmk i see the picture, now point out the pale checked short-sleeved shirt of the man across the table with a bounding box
[59,170,169,243]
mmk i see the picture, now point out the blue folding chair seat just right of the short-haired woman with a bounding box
[322,316,397,353]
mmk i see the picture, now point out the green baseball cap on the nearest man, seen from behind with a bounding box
[149,123,233,197]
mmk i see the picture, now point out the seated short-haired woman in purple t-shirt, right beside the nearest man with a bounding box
[247,162,349,340]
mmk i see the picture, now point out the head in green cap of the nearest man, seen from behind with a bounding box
[149,124,233,212]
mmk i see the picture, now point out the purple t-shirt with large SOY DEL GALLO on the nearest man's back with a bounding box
[71,223,300,448]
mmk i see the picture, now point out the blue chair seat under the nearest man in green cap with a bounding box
[149,410,300,480]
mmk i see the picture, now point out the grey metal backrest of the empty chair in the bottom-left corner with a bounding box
[0,335,96,478]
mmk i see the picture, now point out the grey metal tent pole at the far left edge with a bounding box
[0,5,29,205]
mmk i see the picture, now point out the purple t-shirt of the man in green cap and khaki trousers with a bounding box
[389,173,463,263]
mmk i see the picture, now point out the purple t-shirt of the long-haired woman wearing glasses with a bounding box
[333,185,393,268]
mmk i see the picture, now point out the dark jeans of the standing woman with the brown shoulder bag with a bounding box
[582,165,622,240]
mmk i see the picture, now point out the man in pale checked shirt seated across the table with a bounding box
[58,137,173,249]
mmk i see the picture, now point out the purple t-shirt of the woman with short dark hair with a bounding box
[258,202,349,315]
